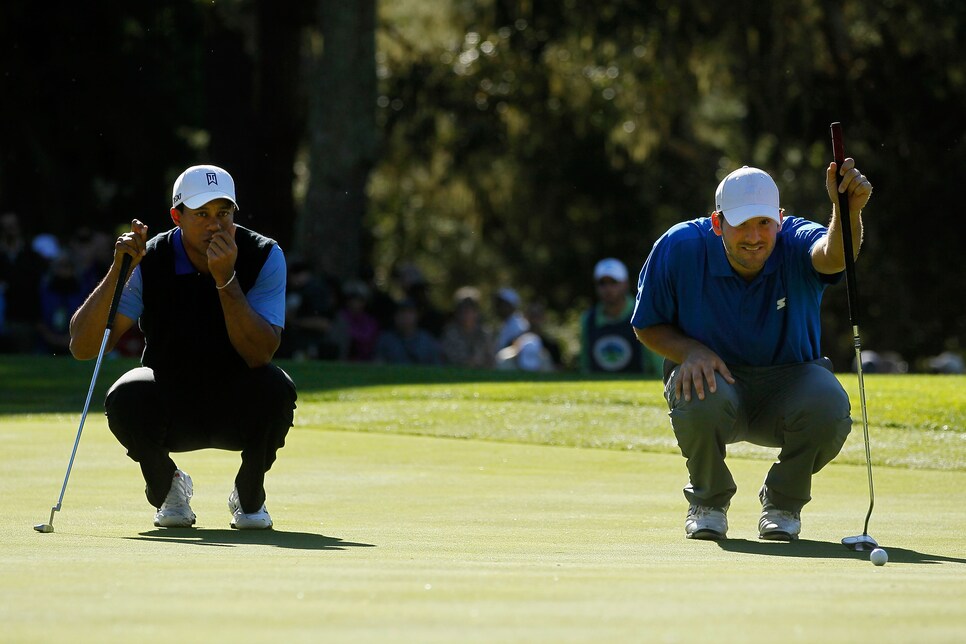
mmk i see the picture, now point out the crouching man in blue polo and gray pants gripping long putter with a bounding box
[631,159,872,541]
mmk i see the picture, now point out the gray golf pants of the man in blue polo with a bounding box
[664,359,852,511]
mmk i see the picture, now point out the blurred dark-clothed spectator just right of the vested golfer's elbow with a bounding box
[277,260,349,360]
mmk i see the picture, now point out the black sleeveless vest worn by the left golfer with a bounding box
[140,226,275,378]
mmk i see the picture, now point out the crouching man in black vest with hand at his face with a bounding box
[70,166,296,529]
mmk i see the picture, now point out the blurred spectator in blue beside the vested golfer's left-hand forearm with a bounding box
[37,252,90,355]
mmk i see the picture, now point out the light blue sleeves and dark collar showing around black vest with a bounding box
[117,228,287,328]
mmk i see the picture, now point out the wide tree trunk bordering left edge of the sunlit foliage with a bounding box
[296,0,377,279]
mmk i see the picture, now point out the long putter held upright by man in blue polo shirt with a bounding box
[831,122,879,551]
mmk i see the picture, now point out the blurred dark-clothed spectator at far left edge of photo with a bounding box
[0,212,47,353]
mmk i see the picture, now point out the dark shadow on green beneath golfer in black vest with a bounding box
[131,528,376,550]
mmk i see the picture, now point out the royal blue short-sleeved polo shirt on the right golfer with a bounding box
[631,217,842,366]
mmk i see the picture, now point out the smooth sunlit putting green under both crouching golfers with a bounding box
[0,415,966,642]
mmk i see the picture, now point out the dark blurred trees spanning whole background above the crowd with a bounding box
[0,0,966,367]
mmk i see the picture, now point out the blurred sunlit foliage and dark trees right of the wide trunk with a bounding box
[369,0,966,367]
